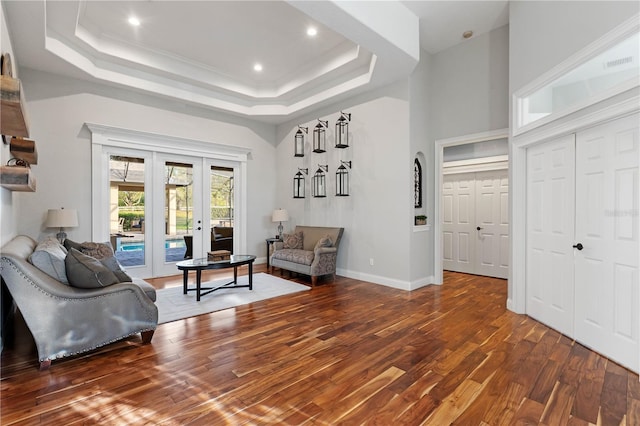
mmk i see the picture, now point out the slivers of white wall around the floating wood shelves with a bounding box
[0,4,18,246]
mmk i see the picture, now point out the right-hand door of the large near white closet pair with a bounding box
[575,115,640,371]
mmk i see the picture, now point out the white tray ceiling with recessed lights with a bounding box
[2,0,508,122]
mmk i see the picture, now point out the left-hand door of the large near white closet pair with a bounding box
[526,135,575,336]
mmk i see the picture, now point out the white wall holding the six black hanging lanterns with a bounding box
[271,81,413,289]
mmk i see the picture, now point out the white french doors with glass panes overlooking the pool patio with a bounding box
[96,146,239,278]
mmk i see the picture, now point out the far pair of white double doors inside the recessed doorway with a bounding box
[442,170,509,278]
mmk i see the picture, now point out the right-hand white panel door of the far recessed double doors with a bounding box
[475,170,509,278]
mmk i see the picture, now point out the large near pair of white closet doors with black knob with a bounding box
[526,114,640,372]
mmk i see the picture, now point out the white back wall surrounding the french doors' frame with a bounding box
[17,68,276,257]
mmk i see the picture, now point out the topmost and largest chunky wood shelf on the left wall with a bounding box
[0,75,29,137]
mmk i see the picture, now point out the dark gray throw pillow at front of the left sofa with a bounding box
[64,249,118,288]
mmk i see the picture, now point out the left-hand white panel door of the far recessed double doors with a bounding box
[442,173,477,274]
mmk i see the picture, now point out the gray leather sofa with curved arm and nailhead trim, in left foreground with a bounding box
[0,236,158,369]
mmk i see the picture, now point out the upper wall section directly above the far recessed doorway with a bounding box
[429,24,510,140]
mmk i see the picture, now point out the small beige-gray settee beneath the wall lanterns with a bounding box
[270,226,344,286]
